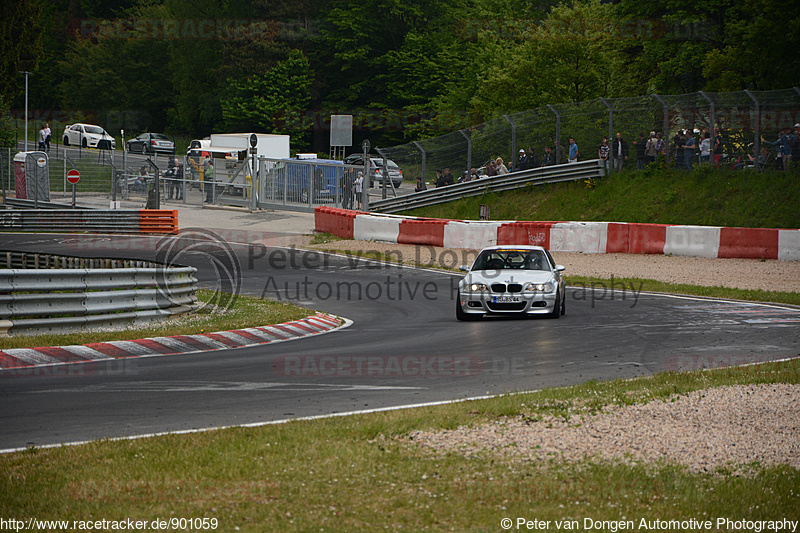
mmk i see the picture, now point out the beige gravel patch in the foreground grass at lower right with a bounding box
[407,384,800,472]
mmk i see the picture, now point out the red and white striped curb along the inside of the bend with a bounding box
[0,313,351,370]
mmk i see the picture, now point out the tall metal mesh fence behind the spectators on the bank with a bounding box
[382,88,800,183]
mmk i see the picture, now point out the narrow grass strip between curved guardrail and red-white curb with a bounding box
[0,289,313,350]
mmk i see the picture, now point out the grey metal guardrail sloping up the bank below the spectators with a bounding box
[369,159,605,213]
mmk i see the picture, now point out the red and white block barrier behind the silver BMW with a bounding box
[315,207,800,261]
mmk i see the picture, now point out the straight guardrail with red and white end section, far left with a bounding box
[0,209,178,234]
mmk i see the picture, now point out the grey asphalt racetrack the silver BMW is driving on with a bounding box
[0,234,800,449]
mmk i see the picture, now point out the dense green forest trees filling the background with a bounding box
[14,0,800,145]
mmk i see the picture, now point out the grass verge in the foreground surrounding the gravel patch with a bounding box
[0,360,800,532]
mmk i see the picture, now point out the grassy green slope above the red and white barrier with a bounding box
[404,164,800,229]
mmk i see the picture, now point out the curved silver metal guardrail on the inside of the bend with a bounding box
[0,252,197,336]
